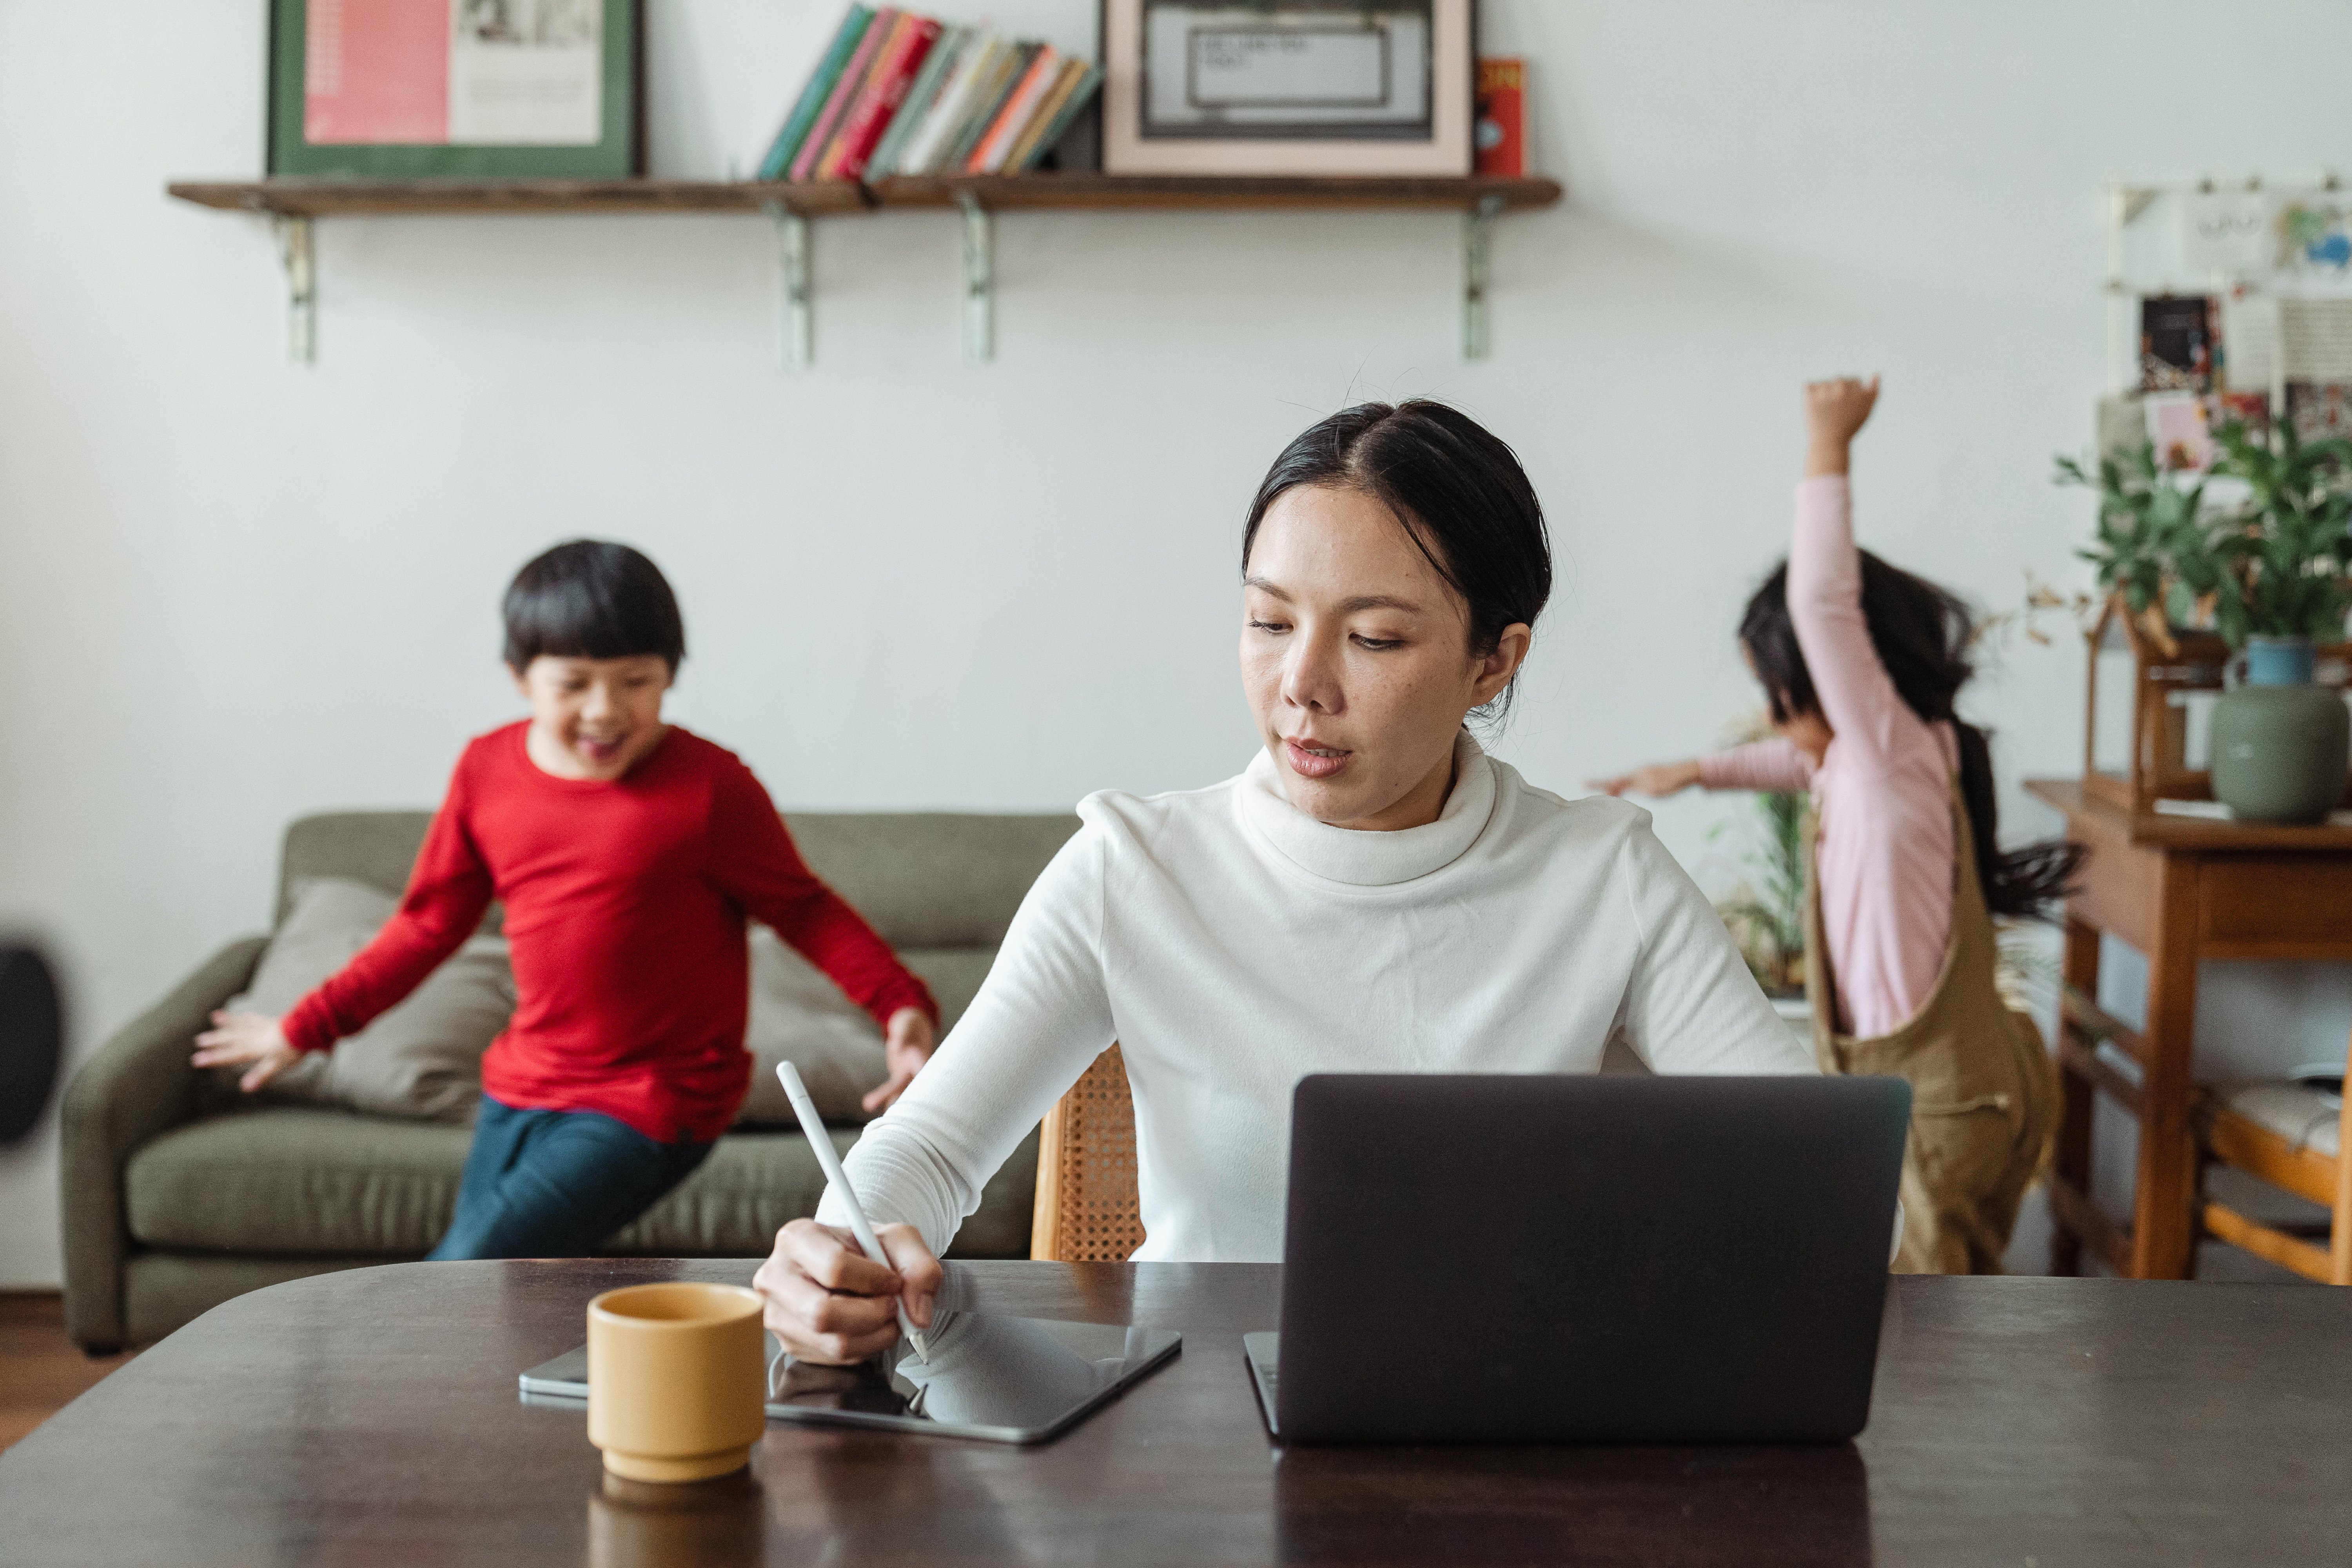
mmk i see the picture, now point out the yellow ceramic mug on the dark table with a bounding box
[588,1283,767,1481]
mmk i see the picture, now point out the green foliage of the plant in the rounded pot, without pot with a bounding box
[2056,421,2352,649]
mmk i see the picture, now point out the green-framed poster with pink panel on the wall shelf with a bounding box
[268,0,644,179]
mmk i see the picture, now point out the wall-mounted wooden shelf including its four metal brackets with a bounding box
[167,174,1562,365]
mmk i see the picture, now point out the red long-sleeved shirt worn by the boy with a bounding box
[280,724,938,1143]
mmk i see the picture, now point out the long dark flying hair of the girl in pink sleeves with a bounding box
[1740,550,2084,919]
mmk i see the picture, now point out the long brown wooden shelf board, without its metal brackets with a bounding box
[167,174,1559,219]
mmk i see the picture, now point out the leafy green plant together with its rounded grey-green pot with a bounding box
[2058,421,2352,823]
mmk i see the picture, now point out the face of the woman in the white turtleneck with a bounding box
[1242,486,1529,830]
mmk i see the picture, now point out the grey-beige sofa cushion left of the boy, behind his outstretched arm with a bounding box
[216,877,515,1122]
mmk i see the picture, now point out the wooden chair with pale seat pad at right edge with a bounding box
[2197,1034,2352,1286]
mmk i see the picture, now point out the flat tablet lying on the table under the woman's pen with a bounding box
[522,1312,1183,1443]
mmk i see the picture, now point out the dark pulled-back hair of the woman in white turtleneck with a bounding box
[1242,397,1552,719]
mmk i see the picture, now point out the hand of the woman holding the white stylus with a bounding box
[750,1220,948,1366]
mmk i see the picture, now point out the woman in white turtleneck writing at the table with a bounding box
[755,402,1813,1361]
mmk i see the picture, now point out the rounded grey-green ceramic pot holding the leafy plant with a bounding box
[2213,637,2352,823]
